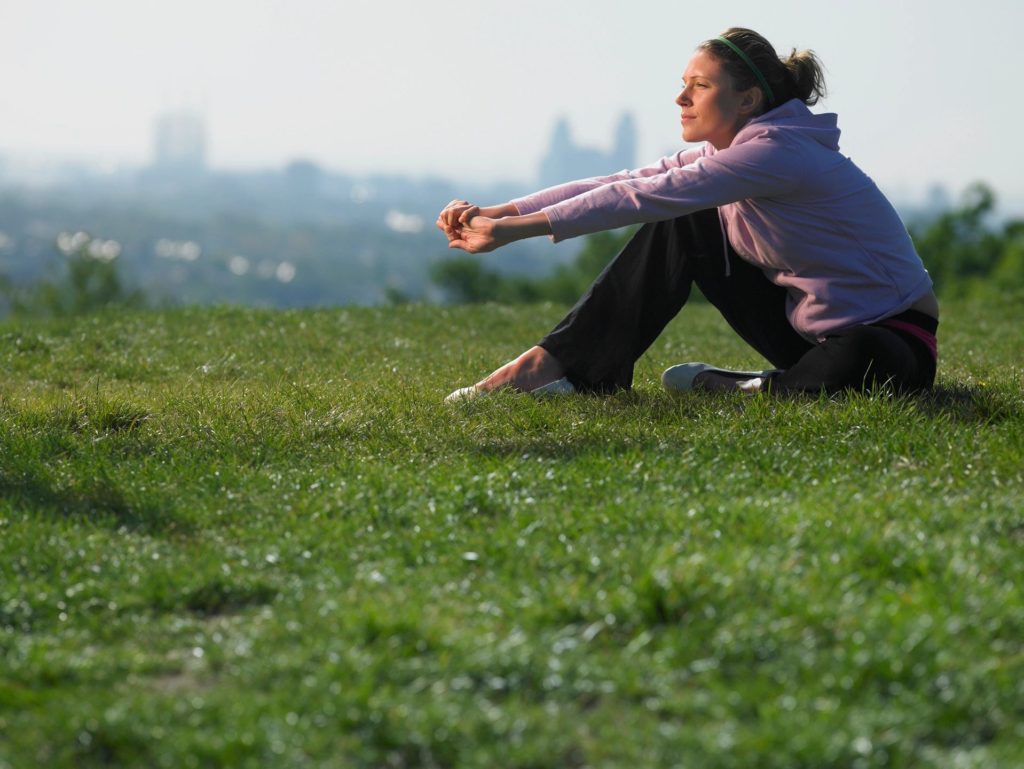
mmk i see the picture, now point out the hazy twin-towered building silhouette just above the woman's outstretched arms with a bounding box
[538,113,637,186]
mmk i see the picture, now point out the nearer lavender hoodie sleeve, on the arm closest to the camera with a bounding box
[541,127,807,243]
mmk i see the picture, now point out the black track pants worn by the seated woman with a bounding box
[539,209,937,393]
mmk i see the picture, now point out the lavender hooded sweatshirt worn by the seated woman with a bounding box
[512,99,932,340]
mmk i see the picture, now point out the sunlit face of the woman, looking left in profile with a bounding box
[676,50,761,149]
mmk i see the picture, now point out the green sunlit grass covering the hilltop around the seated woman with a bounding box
[0,299,1024,769]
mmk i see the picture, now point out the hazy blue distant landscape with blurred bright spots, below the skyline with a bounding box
[0,177,561,315]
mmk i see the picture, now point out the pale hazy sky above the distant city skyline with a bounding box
[0,0,1024,211]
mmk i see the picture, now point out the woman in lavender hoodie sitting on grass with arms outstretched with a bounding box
[437,28,939,399]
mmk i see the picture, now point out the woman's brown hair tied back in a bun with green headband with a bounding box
[697,27,825,112]
